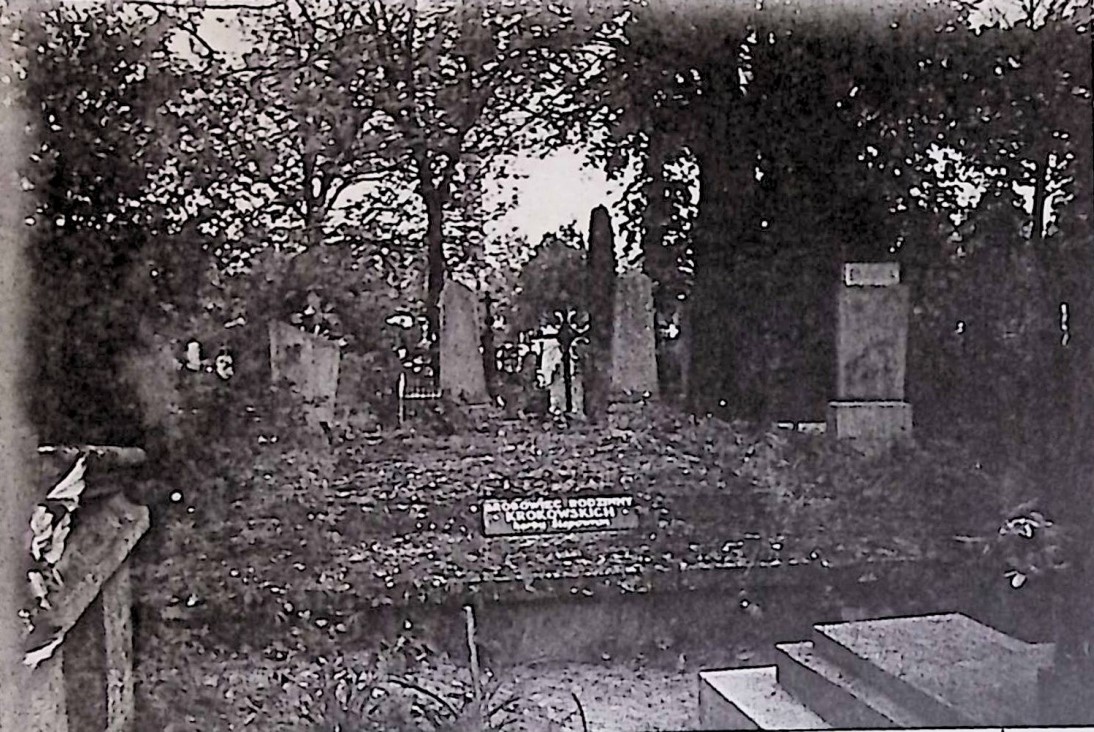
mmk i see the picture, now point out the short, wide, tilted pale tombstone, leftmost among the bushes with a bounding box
[269,321,341,427]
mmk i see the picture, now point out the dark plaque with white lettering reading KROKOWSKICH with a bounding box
[482,496,638,536]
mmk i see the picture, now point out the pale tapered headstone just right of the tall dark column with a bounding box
[612,271,657,402]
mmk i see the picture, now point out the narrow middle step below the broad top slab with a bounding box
[775,640,924,729]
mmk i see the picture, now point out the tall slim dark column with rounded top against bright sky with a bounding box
[585,206,616,423]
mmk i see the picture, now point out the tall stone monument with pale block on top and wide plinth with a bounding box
[827,263,911,446]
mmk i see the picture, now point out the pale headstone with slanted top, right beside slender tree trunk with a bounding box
[440,280,489,404]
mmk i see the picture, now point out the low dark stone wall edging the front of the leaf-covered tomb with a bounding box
[255,553,1044,667]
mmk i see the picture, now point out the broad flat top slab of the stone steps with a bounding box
[813,613,1052,727]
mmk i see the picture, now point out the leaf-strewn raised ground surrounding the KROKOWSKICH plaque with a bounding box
[134,408,987,627]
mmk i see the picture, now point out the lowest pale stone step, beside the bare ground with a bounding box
[699,666,829,730]
